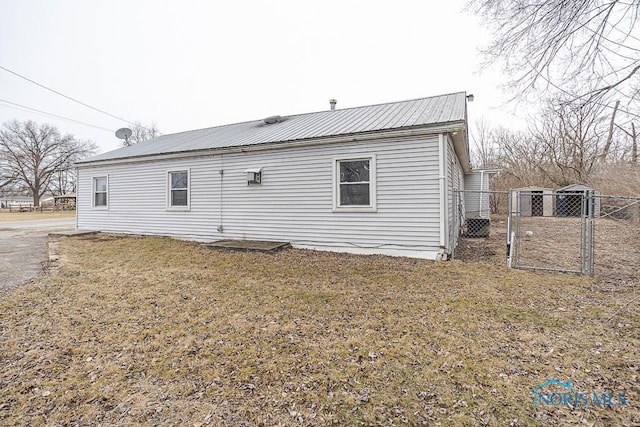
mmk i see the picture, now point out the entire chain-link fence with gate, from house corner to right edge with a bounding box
[450,189,640,287]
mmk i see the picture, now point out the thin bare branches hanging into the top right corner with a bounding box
[467,0,640,102]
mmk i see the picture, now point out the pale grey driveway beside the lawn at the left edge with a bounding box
[0,218,75,296]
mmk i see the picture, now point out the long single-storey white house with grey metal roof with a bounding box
[76,92,471,259]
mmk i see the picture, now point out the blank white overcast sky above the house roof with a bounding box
[0,0,522,152]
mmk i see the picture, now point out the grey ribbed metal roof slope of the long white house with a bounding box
[78,92,466,164]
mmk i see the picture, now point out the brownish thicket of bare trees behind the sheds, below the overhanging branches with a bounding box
[472,95,640,196]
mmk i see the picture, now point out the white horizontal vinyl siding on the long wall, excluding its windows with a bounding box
[77,135,440,258]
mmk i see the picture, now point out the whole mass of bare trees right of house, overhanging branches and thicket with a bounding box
[467,0,640,202]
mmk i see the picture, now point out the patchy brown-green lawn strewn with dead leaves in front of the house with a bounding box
[0,234,640,426]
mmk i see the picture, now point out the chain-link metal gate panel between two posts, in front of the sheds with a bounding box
[507,191,596,276]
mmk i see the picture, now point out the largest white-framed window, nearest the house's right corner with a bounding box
[334,156,376,211]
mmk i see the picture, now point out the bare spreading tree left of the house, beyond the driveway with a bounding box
[0,120,96,206]
